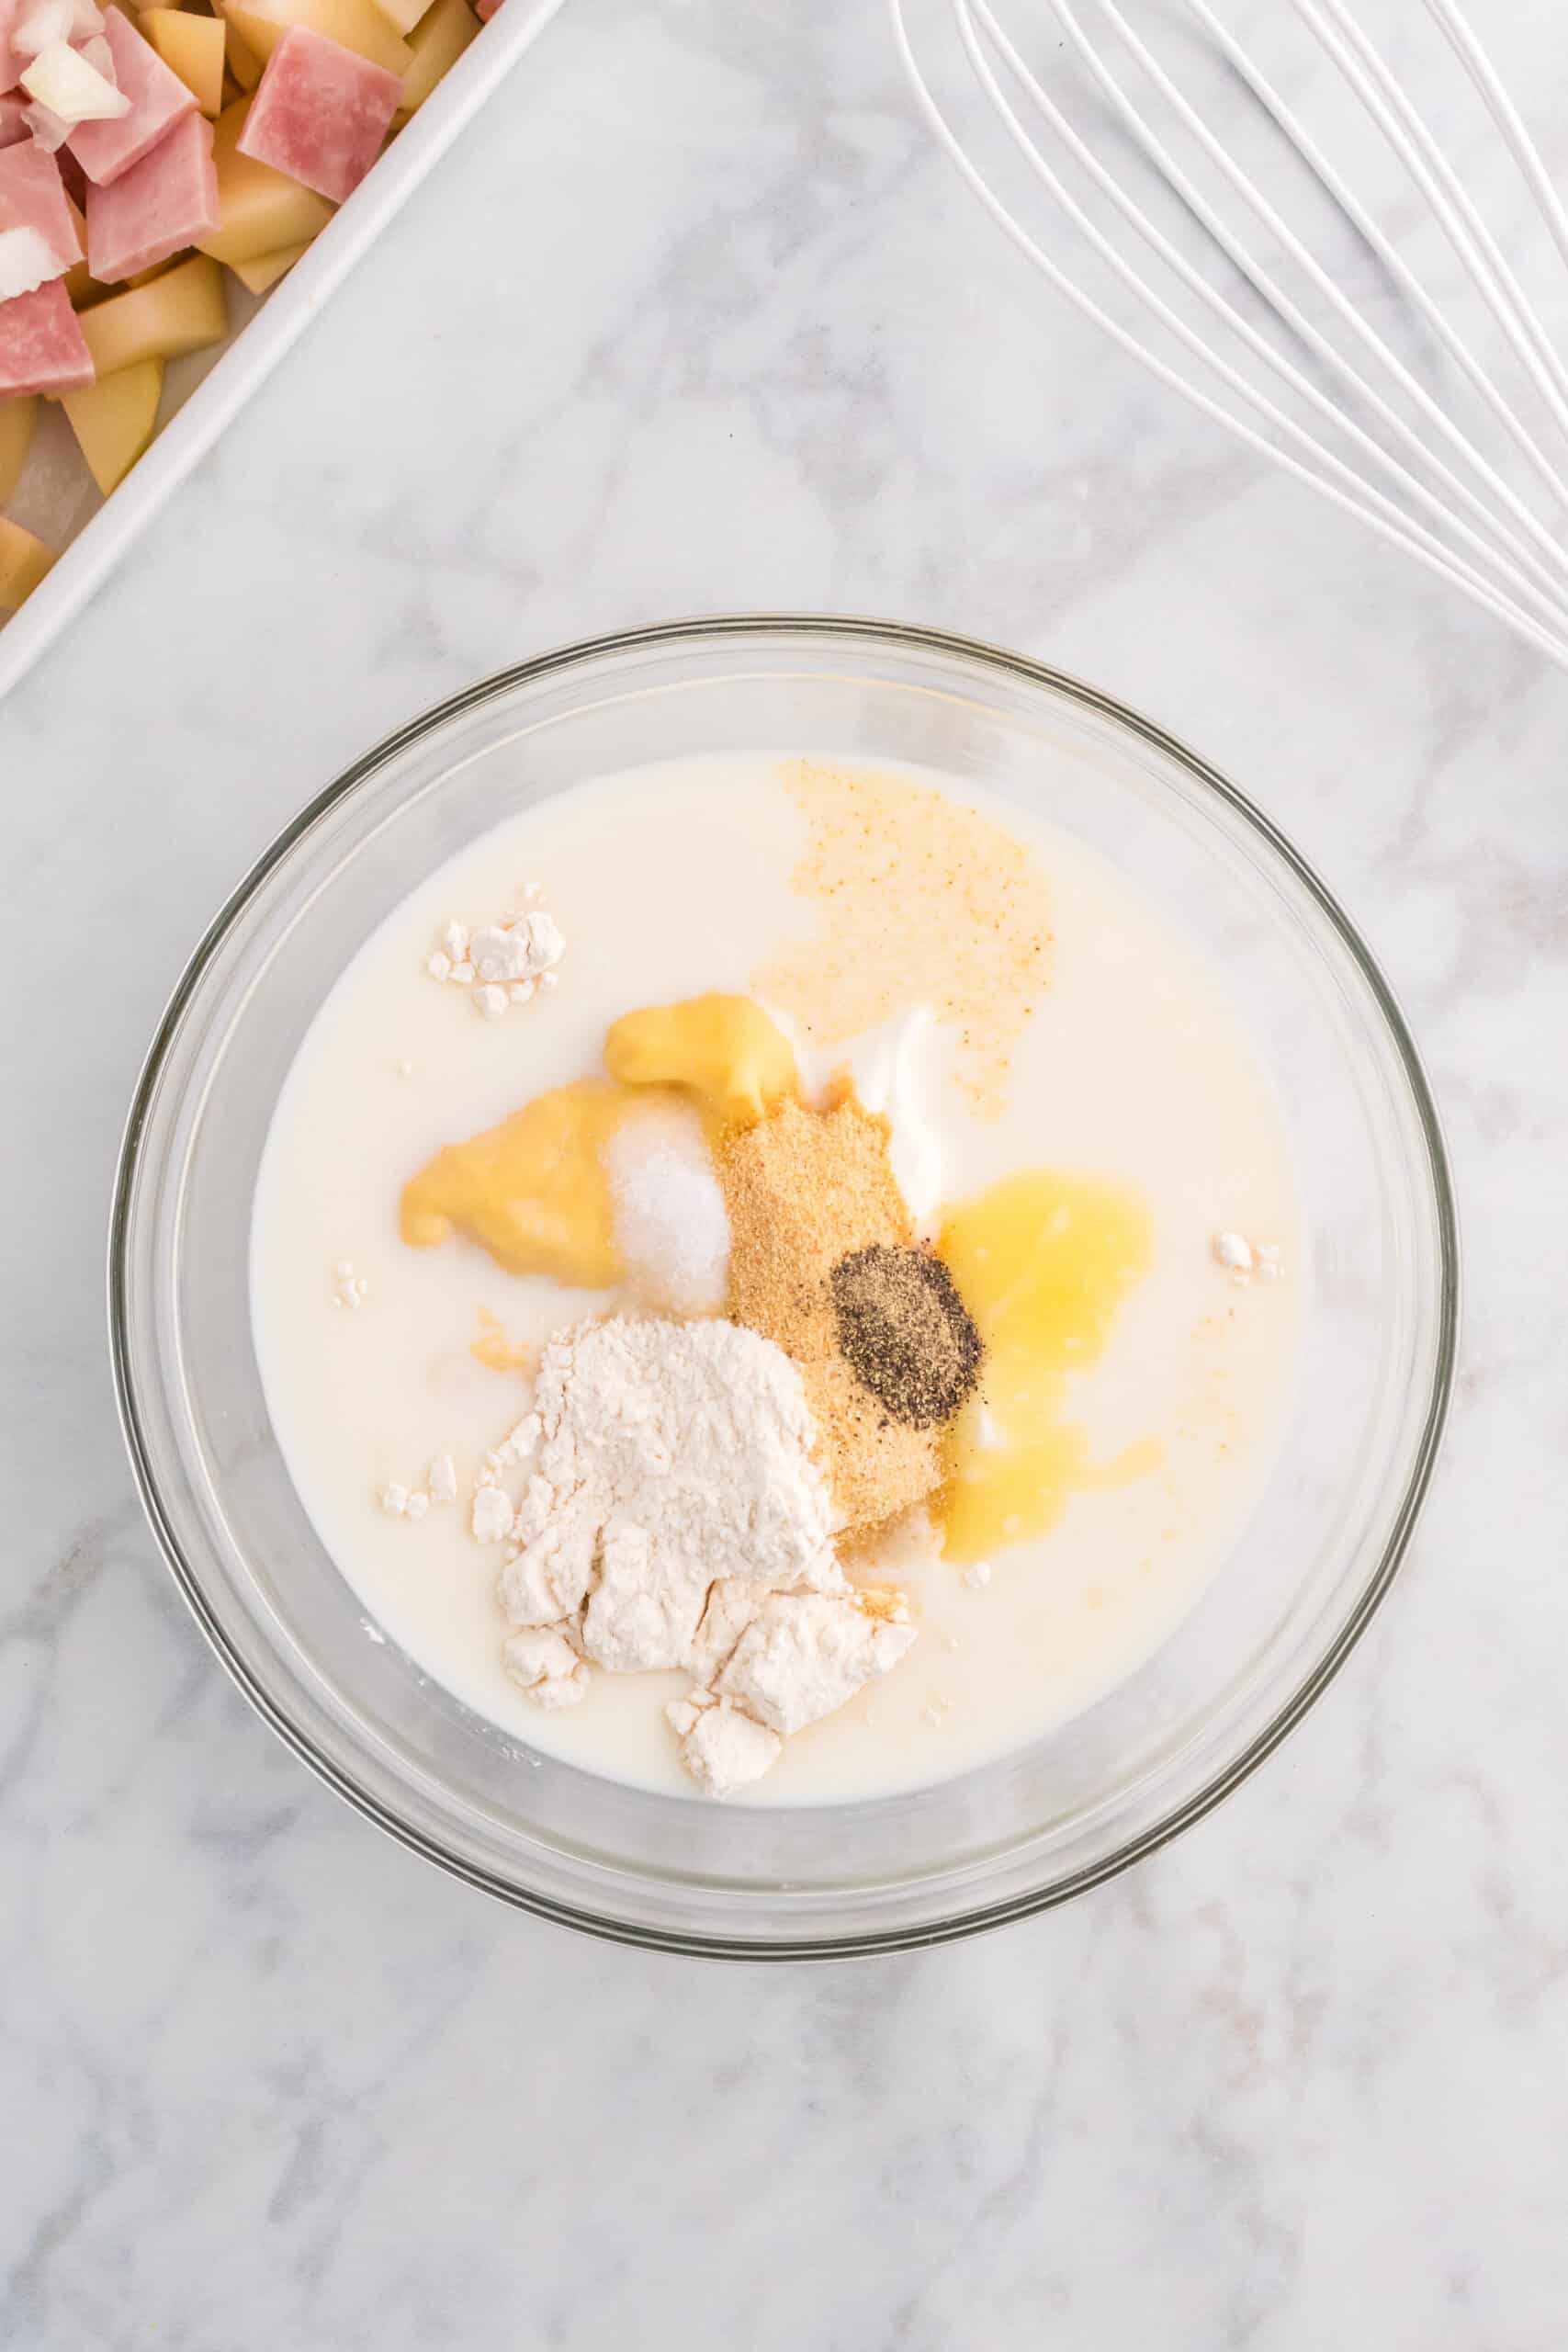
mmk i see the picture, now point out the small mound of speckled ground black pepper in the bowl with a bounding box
[832,1242,980,1428]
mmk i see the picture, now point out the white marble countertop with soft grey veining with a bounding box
[0,0,1568,2352]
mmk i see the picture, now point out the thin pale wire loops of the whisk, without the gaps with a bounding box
[888,0,1568,668]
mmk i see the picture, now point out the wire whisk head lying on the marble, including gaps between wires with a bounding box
[888,0,1568,668]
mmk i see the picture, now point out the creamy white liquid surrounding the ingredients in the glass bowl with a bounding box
[252,755,1304,1804]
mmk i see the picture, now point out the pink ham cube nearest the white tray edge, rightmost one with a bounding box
[235,24,402,205]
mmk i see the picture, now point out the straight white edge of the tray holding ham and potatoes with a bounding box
[0,0,562,701]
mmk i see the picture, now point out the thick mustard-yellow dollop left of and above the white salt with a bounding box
[398,995,797,1288]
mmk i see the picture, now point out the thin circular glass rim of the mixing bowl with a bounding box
[108,612,1460,1962]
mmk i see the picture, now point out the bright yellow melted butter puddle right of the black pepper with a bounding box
[938,1169,1161,1562]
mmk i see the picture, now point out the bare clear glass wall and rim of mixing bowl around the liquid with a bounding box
[110,618,1458,1959]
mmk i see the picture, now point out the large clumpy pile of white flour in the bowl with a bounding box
[472,1315,915,1797]
